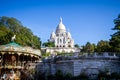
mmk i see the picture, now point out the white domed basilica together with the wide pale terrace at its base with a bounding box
[42,18,77,53]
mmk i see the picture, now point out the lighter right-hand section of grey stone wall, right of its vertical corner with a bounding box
[74,58,120,76]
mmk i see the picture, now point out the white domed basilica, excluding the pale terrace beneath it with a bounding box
[49,18,74,48]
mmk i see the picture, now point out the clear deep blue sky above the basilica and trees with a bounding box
[0,0,120,46]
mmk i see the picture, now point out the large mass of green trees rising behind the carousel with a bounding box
[0,16,41,48]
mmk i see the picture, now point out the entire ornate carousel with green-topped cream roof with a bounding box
[0,34,41,77]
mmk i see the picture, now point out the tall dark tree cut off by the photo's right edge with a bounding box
[110,14,120,52]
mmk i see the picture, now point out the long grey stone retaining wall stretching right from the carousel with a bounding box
[36,52,120,76]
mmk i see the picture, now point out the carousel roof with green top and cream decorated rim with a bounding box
[0,42,41,56]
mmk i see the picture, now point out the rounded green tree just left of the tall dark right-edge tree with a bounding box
[97,40,111,52]
